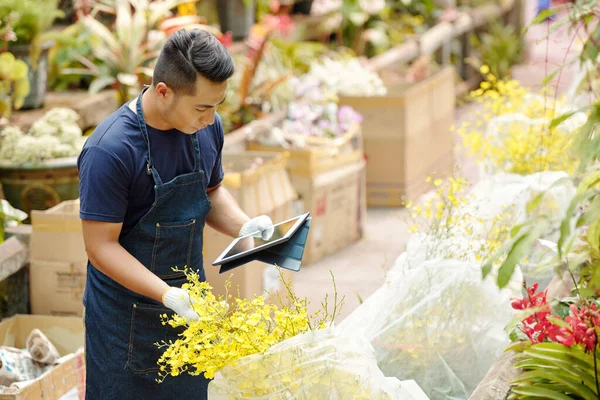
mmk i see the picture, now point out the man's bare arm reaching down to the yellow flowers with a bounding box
[82,219,169,303]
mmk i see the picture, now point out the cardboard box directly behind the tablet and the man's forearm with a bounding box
[203,151,297,301]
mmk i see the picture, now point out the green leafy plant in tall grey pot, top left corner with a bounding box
[0,0,63,108]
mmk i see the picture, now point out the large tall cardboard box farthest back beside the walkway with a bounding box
[340,67,455,207]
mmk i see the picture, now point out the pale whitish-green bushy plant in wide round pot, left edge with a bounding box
[0,108,85,214]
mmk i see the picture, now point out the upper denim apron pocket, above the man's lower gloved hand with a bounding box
[151,219,196,279]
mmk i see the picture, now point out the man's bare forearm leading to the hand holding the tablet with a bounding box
[206,186,250,238]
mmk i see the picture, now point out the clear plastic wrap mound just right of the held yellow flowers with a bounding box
[340,259,519,400]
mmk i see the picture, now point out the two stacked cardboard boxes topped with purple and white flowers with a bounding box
[248,124,366,264]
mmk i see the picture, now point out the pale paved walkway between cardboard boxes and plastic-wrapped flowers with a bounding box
[294,1,573,322]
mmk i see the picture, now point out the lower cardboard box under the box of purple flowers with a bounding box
[292,160,366,264]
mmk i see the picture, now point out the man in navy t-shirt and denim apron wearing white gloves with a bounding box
[78,30,273,400]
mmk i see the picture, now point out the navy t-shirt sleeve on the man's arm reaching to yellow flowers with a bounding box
[78,146,129,223]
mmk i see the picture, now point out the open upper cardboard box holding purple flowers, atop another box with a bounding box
[247,124,364,177]
